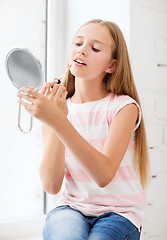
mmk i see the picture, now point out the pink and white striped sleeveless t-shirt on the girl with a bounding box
[56,93,146,228]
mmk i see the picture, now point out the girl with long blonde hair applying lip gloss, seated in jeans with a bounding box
[18,20,148,240]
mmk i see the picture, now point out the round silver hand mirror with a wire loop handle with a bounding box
[6,48,43,133]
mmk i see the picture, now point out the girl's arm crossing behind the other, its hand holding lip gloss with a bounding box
[40,81,68,194]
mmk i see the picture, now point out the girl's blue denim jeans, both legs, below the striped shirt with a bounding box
[43,206,140,240]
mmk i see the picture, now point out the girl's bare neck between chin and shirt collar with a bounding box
[71,78,108,104]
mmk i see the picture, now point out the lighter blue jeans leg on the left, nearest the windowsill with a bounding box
[43,206,89,240]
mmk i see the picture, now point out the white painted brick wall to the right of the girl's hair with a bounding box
[130,0,167,240]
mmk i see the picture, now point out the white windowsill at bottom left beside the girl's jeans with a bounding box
[0,215,46,240]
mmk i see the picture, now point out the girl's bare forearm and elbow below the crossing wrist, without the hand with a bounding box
[40,124,65,194]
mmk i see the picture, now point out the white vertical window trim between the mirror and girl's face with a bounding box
[47,0,67,81]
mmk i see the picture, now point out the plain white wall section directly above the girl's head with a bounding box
[66,0,129,54]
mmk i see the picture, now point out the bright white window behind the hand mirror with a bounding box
[0,0,46,220]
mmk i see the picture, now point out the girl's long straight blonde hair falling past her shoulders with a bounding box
[64,19,149,188]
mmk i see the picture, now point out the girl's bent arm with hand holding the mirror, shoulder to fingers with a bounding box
[19,88,138,187]
